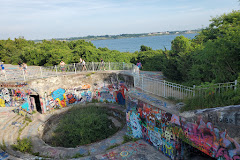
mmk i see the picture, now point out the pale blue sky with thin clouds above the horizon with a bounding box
[0,0,240,40]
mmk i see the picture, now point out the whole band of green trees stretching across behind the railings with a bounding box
[0,11,240,85]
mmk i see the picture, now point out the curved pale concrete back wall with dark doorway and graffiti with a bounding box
[0,72,133,115]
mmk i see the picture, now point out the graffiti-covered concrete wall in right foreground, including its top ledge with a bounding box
[126,91,240,160]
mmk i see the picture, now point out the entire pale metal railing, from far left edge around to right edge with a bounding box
[0,62,237,99]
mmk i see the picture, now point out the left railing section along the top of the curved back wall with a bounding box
[0,62,136,81]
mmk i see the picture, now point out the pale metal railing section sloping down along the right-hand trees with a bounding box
[134,74,237,99]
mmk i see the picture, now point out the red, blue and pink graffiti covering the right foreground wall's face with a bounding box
[126,95,240,160]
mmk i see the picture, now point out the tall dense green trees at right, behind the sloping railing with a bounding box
[134,11,240,85]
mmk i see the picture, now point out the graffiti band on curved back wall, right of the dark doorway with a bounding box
[43,81,128,111]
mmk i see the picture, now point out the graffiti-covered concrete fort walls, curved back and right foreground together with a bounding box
[0,71,240,160]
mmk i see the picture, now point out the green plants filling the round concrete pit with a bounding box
[51,105,118,147]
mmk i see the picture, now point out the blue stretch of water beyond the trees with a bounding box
[91,33,197,53]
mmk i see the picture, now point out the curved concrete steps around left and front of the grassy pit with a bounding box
[0,104,152,160]
